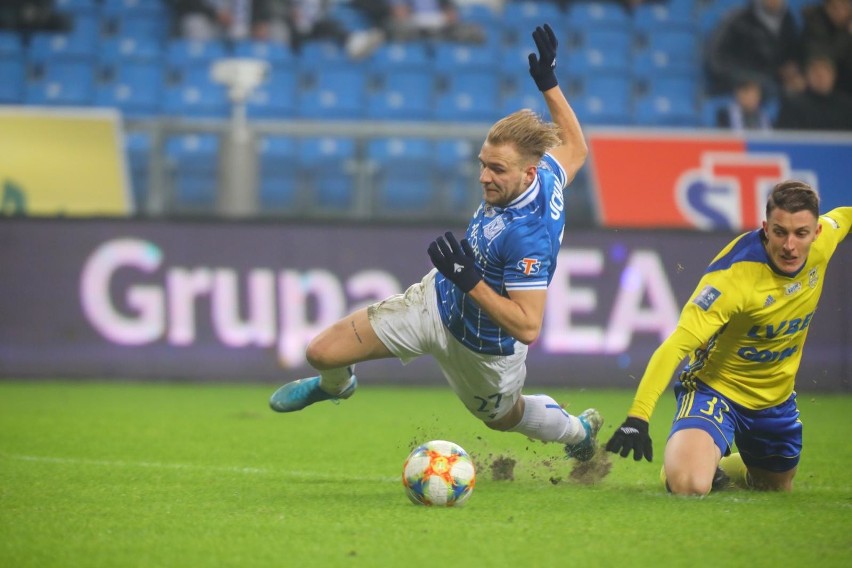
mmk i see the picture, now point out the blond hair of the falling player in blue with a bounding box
[485,109,562,164]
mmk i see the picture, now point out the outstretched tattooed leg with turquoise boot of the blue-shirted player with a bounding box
[269,308,393,412]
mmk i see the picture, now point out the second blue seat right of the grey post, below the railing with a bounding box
[298,137,356,213]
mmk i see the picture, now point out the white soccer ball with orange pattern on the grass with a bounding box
[402,440,476,507]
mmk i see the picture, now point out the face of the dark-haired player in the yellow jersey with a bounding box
[763,209,822,272]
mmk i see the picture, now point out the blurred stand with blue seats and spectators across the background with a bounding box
[0,0,852,223]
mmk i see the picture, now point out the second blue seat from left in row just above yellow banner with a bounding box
[24,61,95,106]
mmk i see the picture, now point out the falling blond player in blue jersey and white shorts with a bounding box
[269,24,603,461]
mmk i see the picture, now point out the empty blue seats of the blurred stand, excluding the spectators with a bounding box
[0,0,792,217]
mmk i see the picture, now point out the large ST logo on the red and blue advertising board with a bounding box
[675,152,818,231]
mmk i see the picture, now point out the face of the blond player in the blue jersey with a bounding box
[479,142,535,207]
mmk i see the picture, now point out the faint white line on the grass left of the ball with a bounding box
[0,453,400,482]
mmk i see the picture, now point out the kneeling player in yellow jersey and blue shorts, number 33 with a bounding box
[606,181,852,495]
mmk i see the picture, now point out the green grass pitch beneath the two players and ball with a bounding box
[0,381,852,568]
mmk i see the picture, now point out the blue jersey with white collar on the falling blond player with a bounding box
[435,154,566,355]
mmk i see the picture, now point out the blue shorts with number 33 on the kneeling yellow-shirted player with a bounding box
[669,381,802,473]
